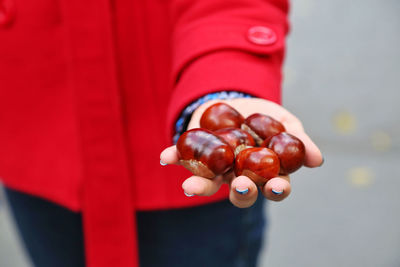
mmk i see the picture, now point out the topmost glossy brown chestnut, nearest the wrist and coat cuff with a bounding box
[200,103,244,131]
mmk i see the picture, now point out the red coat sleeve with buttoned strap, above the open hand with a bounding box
[167,0,289,141]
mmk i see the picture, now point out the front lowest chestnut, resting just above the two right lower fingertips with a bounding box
[234,147,279,186]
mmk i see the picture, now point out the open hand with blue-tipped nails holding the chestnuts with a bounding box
[160,98,323,208]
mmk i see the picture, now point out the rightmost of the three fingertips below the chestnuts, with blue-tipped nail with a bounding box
[262,176,292,201]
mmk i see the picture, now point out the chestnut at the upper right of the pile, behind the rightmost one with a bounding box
[242,113,285,145]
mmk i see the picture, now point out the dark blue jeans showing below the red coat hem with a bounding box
[6,188,265,267]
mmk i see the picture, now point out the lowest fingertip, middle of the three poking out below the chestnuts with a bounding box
[229,176,257,208]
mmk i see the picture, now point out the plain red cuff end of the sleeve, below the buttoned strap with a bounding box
[167,50,283,140]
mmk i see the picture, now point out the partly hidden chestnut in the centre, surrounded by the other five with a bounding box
[214,128,255,155]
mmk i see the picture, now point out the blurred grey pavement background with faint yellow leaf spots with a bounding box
[0,0,400,267]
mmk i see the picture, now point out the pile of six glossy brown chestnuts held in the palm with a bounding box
[176,103,305,186]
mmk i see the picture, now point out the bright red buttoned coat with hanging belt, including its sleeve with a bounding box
[0,0,288,267]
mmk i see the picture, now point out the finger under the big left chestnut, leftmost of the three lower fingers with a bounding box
[182,176,223,196]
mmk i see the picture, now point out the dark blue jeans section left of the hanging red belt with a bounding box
[5,188,85,267]
